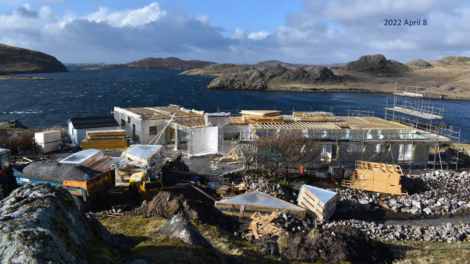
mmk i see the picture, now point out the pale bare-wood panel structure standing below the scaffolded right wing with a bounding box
[342,161,408,195]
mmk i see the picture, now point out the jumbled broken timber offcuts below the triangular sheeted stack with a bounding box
[238,212,285,239]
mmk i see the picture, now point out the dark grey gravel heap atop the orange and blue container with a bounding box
[23,161,102,181]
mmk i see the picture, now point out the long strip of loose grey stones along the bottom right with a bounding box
[332,220,470,243]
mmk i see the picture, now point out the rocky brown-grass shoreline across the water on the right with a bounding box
[181,54,470,100]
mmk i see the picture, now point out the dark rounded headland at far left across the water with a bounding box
[0,44,67,75]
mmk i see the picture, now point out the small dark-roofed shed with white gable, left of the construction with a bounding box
[67,116,120,146]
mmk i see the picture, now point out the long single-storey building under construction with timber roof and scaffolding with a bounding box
[114,98,456,166]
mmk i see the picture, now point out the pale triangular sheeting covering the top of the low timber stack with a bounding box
[220,190,303,210]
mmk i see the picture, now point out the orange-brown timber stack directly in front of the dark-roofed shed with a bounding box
[82,130,128,150]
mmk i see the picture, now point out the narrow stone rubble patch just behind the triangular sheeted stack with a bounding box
[242,174,297,203]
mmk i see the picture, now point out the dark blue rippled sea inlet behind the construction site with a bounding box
[0,66,470,142]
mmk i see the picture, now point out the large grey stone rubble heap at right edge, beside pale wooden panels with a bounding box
[385,170,470,216]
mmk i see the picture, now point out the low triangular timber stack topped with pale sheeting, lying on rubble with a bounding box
[215,190,305,218]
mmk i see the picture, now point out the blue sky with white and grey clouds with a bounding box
[0,0,470,64]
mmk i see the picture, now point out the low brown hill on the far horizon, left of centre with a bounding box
[107,57,214,70]
